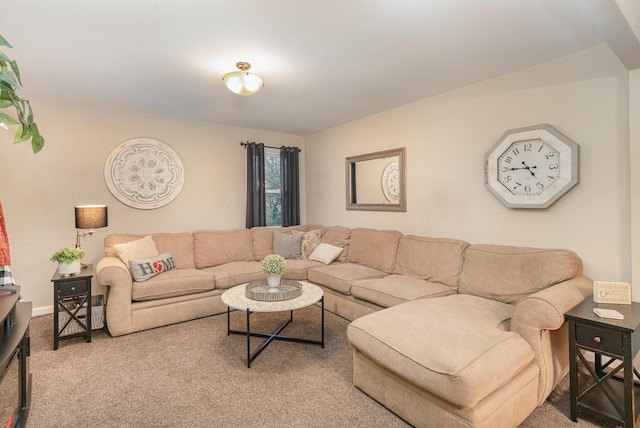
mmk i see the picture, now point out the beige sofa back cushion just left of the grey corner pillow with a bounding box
[193,229,255,269]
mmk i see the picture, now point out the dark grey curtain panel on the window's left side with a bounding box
[246,143,267,228]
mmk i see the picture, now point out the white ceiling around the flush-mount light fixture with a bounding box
[0,0,640,134]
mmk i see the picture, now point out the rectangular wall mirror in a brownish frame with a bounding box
[346,147,407,211]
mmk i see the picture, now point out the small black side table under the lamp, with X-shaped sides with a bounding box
[51,265,94,350]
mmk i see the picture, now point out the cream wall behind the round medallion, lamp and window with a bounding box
[0,102,305,314]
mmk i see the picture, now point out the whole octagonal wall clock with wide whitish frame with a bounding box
[484,124,580,209]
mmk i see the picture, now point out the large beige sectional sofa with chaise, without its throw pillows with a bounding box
[97,225,592,427]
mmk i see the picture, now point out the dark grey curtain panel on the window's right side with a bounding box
[280,146,300,227]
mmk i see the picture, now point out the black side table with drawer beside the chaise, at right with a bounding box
[565,299,640,427]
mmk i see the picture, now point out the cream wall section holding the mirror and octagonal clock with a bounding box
[306,45,631,288]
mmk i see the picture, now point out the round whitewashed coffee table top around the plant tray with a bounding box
[222,281,323,312]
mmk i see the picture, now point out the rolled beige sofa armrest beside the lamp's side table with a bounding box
[96,257,133,336]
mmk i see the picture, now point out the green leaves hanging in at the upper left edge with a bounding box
[0,35,44,153]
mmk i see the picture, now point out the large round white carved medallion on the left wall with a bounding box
[104,138,184,210]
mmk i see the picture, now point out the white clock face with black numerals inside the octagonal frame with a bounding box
[498,138,560,195]
